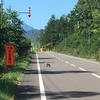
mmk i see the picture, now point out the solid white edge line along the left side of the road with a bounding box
[36,53,47,100]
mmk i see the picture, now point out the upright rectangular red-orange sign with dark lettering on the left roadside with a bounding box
[6,44,14,66]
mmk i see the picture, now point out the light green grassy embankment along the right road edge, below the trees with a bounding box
[53,40,100,61]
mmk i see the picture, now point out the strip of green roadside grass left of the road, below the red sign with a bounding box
[0,53,33,100]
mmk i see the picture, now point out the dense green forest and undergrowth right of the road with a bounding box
[37,0,100,60]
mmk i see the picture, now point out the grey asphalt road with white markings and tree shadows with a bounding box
[16,52,100,100]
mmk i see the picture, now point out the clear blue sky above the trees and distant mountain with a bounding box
[3,0,78,29]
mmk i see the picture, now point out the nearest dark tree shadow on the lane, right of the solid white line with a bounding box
[46,91,100,100]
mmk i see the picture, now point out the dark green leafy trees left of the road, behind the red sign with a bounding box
[0,7,31,68]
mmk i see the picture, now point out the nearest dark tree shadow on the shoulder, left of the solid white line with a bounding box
[15,85,40,100]
